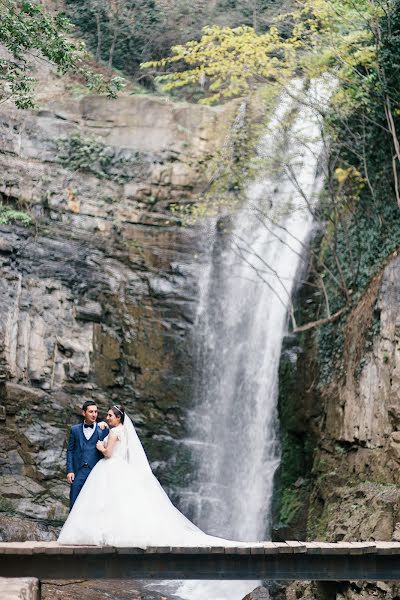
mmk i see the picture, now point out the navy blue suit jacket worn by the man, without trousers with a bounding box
[67,423,109,473]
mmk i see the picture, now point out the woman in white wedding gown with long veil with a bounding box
[58,405,248,548]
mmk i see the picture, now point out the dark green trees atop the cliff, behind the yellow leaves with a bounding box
[66,0,281,88]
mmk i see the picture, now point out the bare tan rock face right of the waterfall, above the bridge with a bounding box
[309,257,400,541]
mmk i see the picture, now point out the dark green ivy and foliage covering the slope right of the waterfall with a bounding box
[316,0,400,383]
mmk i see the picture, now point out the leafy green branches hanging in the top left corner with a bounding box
[0,0,122,108]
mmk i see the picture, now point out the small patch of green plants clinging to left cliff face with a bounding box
[57,133,148,183]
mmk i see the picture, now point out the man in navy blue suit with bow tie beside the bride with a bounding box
[67,400,108,509]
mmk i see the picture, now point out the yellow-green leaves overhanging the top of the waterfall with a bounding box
[142,0,390,106]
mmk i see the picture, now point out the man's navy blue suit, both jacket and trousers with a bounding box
[67,423,109,508]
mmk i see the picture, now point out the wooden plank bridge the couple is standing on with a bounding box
[0,542,400,581]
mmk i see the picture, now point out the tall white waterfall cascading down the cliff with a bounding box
[181,81,329,540]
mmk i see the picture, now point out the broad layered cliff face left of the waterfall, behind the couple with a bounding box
[0,91,231,540]
